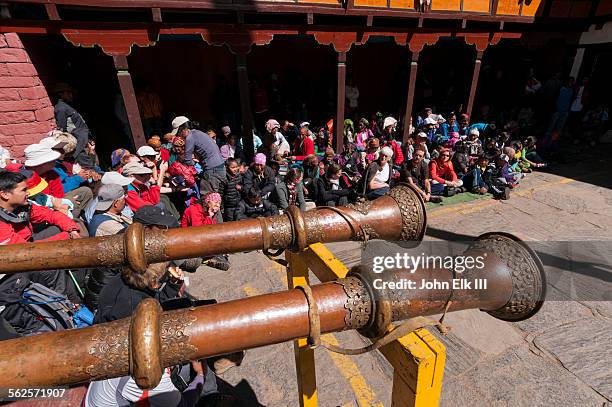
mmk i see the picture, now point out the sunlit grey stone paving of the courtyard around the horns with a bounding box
[190,160,612,407]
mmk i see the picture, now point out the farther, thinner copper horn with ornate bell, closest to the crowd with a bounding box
[0,185,426,274]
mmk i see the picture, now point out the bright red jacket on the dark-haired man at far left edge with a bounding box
[0,204,79,245]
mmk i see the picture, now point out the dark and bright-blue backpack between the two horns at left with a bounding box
[19,283,93,331]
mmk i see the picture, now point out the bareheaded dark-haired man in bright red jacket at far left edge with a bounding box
[0,171,80,244]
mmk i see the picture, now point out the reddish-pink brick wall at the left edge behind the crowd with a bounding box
[0,33,55,158]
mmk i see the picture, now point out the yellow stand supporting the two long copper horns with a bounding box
[285,243,446,407]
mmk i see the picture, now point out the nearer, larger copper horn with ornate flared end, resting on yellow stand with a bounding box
[0,233,545,388]
